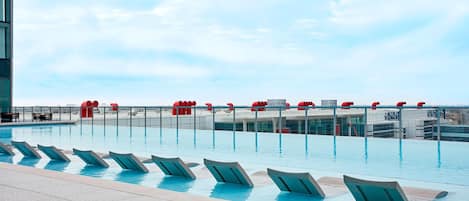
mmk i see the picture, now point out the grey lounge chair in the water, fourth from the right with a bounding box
[151,155,195,179]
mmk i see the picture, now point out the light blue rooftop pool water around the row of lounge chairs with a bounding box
[0,125,469,201]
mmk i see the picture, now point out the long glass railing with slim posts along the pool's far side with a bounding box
[2,106,469,144]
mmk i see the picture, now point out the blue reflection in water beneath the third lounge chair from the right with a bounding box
[210,184,252,201]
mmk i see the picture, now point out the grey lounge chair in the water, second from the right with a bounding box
[267,168,325,198]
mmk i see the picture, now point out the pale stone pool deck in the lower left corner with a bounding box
[0,163,222,201]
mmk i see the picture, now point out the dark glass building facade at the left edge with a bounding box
[0,0,13,112]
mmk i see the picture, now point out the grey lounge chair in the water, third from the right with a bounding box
[204,159,254,187]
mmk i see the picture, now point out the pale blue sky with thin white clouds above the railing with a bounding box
[13,0,469,106]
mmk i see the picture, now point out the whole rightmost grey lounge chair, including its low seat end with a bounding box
[344,175,448,201]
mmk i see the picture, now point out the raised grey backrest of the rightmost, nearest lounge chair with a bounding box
[344,175,408,201]
